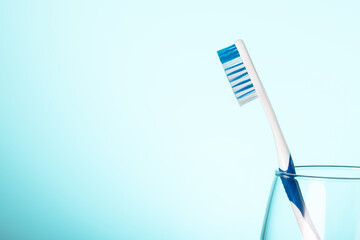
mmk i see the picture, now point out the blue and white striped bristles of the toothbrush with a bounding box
[217,44,257,106]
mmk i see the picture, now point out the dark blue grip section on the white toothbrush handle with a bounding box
[279,155,305,216]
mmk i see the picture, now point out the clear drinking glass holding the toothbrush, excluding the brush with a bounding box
[260,165,360,240]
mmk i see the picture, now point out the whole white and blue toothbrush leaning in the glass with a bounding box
[217,40,320,240]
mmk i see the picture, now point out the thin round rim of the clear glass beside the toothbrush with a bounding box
[275,164,360,180]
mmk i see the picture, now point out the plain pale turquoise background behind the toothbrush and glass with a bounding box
[0,0,360,240]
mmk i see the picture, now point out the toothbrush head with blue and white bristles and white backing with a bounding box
[217,40,258,106]
